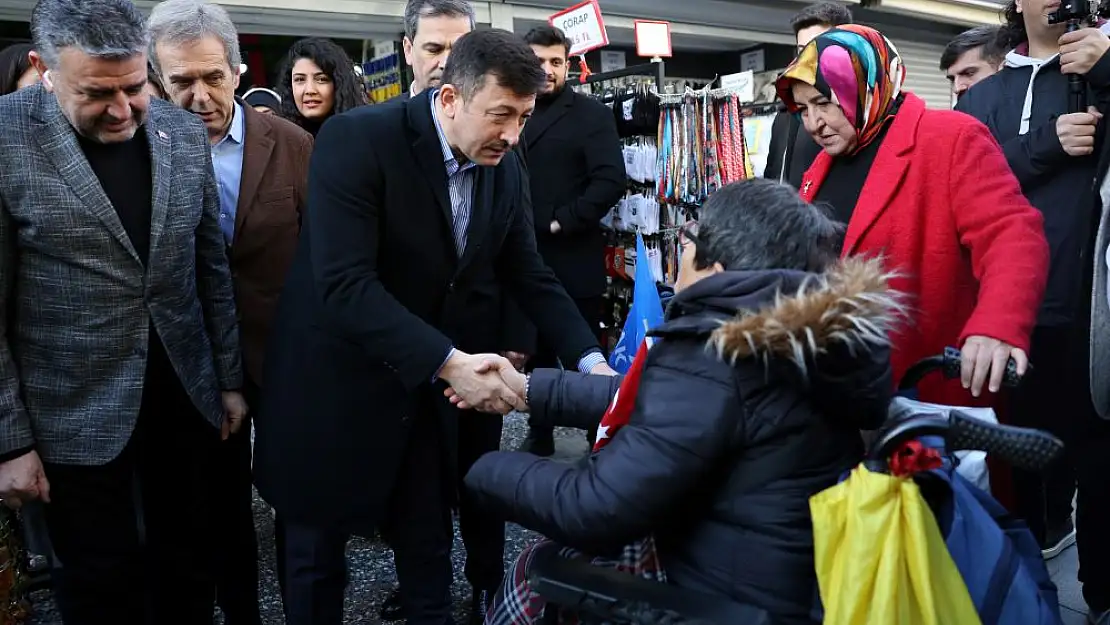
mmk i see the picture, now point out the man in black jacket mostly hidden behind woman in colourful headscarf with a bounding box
[763,2,851,188]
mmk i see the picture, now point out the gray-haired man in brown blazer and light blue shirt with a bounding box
[150,0,312,625]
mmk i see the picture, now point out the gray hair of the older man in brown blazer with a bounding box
[150,0,243,74]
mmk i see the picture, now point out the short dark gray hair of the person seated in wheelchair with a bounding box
[694,178,844,271]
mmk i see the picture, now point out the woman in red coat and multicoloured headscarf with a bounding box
[777,26,1048,405]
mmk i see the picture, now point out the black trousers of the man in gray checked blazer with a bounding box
[46,380,220,625]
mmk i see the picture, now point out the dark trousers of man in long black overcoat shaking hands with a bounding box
[283,414,453,625]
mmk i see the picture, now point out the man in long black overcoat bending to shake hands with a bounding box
[254,30,611,625]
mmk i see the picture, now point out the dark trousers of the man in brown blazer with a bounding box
[214,381,262,625]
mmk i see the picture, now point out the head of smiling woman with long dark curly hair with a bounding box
[276,37,367,135]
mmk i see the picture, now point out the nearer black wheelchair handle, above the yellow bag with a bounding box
[868,410,1063,471]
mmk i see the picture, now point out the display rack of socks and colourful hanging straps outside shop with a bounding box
[575,63,753,346]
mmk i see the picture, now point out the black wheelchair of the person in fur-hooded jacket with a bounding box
[528,347,1063,625]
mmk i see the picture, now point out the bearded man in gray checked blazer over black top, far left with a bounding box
[0,0,246,625]
